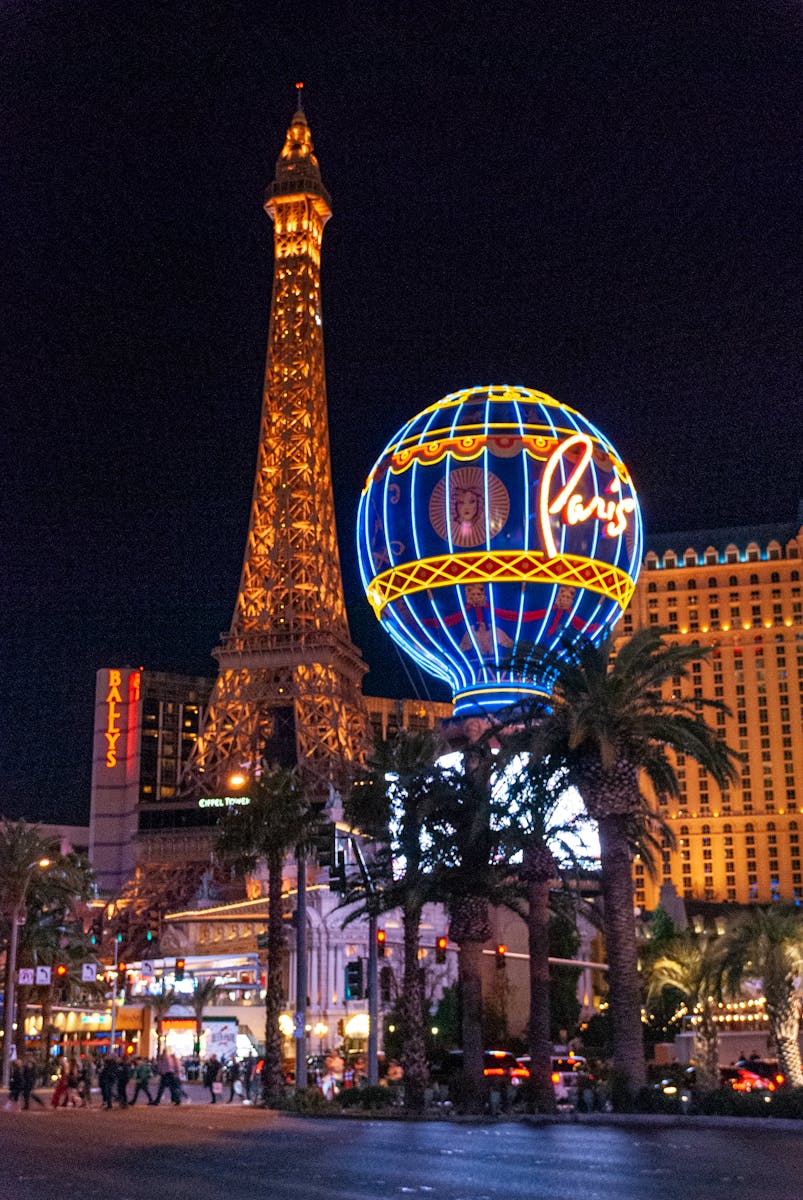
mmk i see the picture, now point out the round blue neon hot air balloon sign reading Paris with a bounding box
[358,386,642,716]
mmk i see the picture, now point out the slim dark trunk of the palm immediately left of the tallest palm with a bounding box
[527,880,555,1112]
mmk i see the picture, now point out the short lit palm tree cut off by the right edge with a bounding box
[721,905,803,1087]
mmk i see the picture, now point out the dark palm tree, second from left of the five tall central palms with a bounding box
[346,730,445,1110]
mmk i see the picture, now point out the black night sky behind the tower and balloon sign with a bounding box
[0,0,803,821]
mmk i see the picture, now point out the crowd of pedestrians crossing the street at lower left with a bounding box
[6,1050,259,1109]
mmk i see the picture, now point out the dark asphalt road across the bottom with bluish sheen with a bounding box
[0,1105,803,1200]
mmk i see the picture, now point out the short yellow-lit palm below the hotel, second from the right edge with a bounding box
[647,931,724,1090]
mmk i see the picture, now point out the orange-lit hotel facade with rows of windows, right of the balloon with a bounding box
[621,505,803,910]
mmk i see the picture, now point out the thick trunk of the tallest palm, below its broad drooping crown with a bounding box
[598,814,647,1106]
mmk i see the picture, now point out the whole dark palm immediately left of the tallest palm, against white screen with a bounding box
[492,730,575,1112]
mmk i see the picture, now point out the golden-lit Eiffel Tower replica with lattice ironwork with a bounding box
[193,96,367,798]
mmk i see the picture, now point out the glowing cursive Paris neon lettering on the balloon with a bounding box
[539,433,636,558]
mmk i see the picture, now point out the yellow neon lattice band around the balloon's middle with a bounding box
[367,550,635,618]
